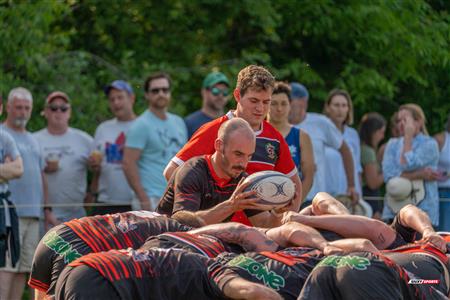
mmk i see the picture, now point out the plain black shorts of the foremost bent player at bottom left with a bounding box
[55,266,120,300]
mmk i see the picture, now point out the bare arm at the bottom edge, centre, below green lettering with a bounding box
[223,277,283,300]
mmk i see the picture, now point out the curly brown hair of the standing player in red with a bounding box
[236,65,275,96]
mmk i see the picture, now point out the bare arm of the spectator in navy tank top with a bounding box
[300,130,315,199]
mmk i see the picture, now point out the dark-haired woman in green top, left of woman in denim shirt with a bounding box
[359,112,386,219]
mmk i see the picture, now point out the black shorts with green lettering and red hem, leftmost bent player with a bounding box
[28,224,92,295]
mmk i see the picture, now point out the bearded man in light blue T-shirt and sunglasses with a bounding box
[123,73,187,210]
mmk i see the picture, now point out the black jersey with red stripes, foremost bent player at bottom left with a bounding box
[62,249,223,300]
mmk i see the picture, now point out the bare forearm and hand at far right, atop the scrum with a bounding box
[398,204,446,252]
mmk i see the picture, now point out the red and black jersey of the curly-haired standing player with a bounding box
[172,111,297,177]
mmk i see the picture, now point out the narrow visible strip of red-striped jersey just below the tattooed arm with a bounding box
[141,232,244,258]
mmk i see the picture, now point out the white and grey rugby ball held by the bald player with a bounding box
[244,171,295,207]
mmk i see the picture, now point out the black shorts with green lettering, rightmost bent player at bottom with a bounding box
[298,252,446,300]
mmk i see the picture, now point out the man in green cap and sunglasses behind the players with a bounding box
[184,72,230,138]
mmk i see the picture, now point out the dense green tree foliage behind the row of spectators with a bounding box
[0,0,450,134]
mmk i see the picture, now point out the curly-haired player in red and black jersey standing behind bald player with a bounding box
[164,65,302,211]
